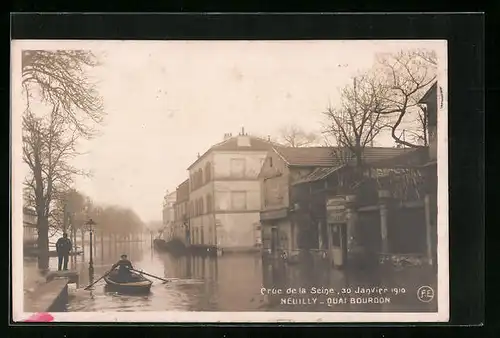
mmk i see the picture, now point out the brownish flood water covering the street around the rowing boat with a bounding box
[39,241,437,312]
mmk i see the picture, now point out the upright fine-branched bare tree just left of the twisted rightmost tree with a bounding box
[323,73,386,167]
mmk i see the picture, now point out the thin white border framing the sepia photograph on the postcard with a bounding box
[9,40,449,323]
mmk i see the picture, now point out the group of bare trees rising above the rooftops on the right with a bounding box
[277,49,437,165]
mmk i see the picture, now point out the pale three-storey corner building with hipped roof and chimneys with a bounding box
[188,130,272,251]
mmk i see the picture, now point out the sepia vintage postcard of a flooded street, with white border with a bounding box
[11,40,449,323]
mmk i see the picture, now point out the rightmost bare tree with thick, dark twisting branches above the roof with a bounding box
[374,49,437,148]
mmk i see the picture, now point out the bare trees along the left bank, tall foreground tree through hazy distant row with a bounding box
[22,50,142,269]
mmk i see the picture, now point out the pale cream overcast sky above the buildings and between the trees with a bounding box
[14,41,442,221]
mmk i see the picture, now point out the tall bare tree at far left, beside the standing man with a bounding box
[22,50,104,269]
